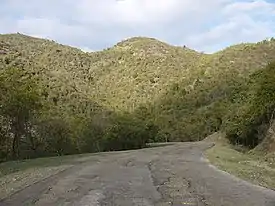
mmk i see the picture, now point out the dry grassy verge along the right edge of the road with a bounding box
[206,134,275,190]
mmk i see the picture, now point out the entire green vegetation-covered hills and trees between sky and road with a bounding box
[0,34,275,161]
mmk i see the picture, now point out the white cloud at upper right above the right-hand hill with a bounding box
[185,0,275,52]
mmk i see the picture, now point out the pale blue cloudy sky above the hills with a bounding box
[0,0,275,53]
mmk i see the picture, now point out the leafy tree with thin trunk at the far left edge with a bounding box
[0,68,42,158]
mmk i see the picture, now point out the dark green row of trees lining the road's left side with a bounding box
[0,68,158,160]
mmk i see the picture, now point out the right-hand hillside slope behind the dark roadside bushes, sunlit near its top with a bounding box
[134,40,275,140]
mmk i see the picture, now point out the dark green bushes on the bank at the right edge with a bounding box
[223,63,275,148]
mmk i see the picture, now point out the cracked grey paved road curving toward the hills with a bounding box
[0,142,275,206]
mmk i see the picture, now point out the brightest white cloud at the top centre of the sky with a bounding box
[77,0,183,24]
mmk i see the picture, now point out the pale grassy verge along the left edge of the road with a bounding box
[0,154,98,200]
